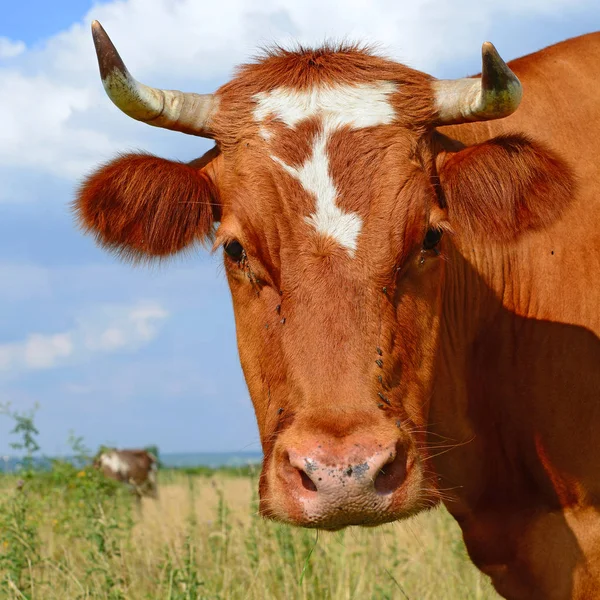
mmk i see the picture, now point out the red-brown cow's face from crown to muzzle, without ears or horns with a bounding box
[206,52,444,528]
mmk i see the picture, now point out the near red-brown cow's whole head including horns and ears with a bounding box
[76,23,568,529]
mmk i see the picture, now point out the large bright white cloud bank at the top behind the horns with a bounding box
[0,0,595,192]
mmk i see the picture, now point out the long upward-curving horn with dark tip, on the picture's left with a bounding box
[92,21,217,138]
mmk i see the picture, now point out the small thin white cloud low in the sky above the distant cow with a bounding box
[0,302,169,375]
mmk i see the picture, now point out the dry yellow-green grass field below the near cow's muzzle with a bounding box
[0,464,497,600]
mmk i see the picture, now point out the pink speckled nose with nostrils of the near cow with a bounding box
[278,437,407,529]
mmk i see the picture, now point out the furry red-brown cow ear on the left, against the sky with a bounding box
[73,154,220,262]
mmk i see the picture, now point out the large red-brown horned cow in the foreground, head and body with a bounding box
[74,22,600,600]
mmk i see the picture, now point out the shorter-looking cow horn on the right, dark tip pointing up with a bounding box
[433,42,523,125]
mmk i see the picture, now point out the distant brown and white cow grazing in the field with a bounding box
[94,448,158,499]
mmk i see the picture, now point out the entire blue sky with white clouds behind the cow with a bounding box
[0,0,600,454]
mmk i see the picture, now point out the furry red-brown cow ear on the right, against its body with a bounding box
[437,135,575,242]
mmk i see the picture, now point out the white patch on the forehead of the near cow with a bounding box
[254,81,397,257]
